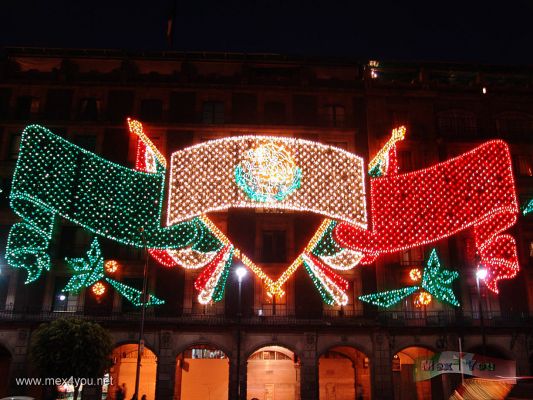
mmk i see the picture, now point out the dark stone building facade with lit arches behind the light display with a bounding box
[0,48,533,400]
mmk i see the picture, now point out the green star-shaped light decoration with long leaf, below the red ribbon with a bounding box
[359,249,460,307]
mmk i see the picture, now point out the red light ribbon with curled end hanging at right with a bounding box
[334,140,519,293]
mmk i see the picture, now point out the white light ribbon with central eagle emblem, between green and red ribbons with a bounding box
[167,136,367,228]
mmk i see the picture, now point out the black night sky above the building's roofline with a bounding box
[0,0,533,64]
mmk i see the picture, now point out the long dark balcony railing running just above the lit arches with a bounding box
[0,307,533,328]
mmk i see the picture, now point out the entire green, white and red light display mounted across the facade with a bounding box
[6,120,518,306]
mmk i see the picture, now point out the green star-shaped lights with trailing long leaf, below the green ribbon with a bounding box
[63,238,165,306]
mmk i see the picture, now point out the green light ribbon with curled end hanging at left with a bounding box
[6,125,199,282]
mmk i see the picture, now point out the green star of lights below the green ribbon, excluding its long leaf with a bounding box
[63,238,105,293]
